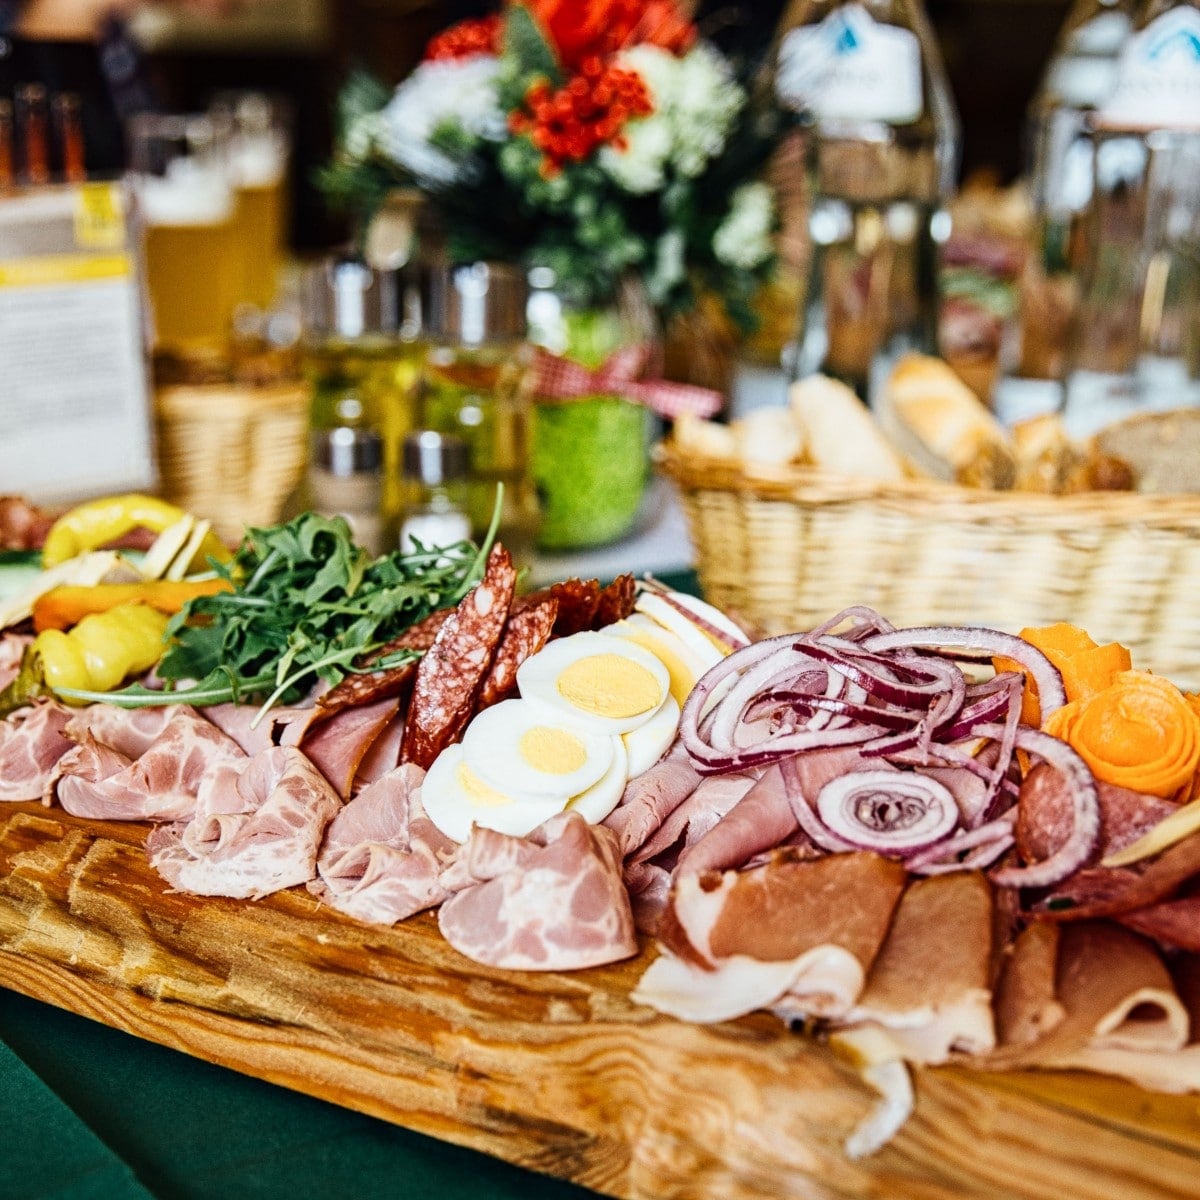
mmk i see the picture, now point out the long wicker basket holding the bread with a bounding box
[655,444,1200,688]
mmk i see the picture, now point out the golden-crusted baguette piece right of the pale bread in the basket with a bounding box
[877,354,1016,490]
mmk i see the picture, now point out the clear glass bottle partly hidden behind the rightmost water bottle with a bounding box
[1018,0,1138,381]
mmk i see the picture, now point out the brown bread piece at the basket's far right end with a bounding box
[1091,408,1200,492]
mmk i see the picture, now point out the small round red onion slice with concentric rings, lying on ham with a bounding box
[816,770,959,858]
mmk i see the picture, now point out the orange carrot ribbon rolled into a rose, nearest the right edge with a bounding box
[1045,671,1200,799]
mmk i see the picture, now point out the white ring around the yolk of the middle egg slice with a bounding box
[462,700,613,803]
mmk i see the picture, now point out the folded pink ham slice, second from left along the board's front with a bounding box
[53,704,246,821]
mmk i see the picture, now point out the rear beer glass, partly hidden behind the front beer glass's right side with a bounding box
[210,91,292,310]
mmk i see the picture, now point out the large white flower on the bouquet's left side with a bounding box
[379,54,505,185]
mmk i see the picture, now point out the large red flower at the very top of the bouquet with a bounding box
[520,0,696,72]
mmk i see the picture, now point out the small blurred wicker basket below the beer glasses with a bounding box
[155,383,308,544]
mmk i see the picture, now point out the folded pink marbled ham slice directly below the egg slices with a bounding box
[438,812,637,971]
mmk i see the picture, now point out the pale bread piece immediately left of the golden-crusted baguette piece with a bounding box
[788,376,906,482]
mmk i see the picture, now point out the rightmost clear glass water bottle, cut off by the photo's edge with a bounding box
[1063,0,1200,434]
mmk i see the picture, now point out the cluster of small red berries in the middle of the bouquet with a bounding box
[509,56,654,175]
